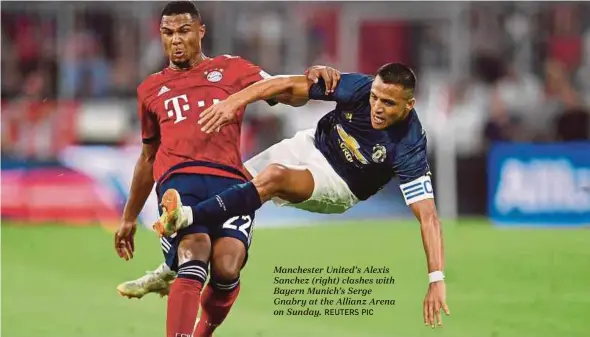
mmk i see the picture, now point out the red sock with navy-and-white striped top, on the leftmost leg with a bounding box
[166,261,206,337]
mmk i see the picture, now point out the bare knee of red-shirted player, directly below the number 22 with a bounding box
[211,237,246,281]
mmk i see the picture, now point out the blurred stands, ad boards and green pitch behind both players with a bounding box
[1,1,590,337]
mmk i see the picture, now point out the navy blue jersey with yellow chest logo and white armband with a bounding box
[309,73,433,205]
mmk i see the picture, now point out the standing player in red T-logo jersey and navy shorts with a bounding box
[115,1,340,337]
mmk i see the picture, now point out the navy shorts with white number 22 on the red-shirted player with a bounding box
[158,174,255,271]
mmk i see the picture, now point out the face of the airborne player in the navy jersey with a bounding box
[369,76,416,130]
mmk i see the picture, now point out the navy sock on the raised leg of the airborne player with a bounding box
[190,182,262,226]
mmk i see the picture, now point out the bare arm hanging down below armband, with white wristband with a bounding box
[410,199,450,328]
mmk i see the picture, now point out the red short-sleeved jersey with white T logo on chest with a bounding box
[137,55,274,183]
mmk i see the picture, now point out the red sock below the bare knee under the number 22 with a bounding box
[193,283,240,337]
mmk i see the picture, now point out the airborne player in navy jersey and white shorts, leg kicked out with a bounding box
[154,63,449,326]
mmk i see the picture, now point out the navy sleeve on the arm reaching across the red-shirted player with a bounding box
[309,73,373,103]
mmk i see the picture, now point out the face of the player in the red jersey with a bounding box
[160,13,205,69]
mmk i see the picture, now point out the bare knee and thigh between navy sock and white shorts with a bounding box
[252,164,315,203]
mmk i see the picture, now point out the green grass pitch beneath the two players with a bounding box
[2,220,590,337]
